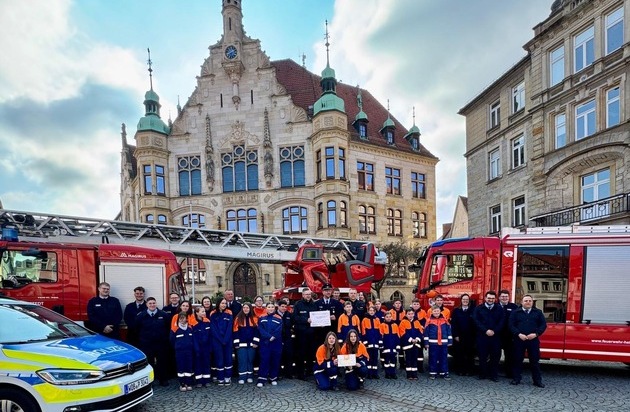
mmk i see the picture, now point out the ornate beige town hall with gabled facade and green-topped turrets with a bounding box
[121,0,438,299]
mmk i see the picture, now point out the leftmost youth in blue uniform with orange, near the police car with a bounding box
[171,312,195,392]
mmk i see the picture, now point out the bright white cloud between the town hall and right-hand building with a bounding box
[314,0,549,232]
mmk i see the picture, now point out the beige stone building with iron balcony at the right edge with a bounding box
[460,0,630,236]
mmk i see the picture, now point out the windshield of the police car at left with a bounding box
[0,303,91,344]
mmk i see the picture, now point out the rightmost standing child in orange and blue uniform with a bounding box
[424,305,453,380]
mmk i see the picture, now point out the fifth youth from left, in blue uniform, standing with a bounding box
[260,302,282,388]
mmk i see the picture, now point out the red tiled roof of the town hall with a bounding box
[271,59,437,159]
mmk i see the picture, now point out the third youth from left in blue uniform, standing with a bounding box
[210,299,234,385]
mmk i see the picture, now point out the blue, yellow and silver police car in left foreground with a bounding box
[0,298,153,412]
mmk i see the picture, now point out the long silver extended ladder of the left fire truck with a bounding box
[0,209,368,263]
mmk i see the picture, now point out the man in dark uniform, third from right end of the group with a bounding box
[473,290,503,382]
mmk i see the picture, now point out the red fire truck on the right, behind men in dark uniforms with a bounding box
[416,226,630,363]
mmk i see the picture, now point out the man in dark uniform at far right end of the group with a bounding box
[509,295,547,388]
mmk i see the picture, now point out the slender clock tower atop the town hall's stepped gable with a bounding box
[221,0,245,109]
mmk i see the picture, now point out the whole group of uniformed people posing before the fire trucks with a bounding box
[88,283,546,391]
